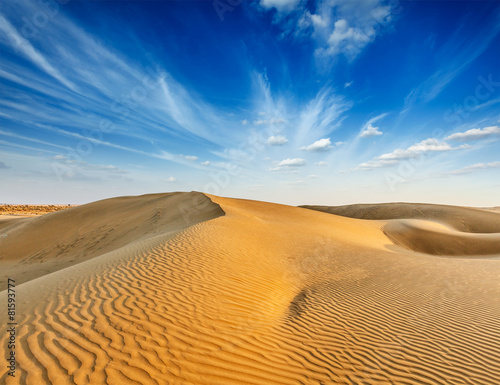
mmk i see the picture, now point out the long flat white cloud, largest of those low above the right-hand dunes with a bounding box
[356,138,469,170]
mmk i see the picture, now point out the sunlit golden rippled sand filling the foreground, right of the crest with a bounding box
[0,199,500,385]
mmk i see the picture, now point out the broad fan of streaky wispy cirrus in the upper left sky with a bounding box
[0,0,244,170]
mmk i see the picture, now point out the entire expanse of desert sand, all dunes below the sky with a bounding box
[0,192,500,385]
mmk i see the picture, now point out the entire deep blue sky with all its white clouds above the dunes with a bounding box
[0,0,500,206]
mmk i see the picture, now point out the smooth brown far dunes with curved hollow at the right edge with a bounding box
[302,203,500,256]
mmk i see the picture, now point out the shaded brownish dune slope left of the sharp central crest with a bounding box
[0,192,224,285]
